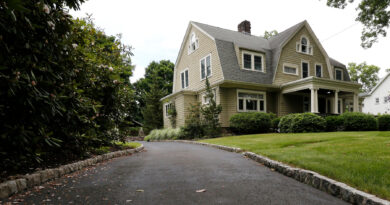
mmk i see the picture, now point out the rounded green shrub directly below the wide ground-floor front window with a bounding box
[230,112,271,134]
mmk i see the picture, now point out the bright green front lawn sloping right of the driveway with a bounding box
[201,131,390,199]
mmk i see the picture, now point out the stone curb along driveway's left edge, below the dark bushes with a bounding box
[0,144,144,199]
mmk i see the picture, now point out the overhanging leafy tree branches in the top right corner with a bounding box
[327,0,390,48]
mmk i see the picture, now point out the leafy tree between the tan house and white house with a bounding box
[348,62,380,92]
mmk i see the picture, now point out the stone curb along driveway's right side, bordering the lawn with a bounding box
[155,140,390,205]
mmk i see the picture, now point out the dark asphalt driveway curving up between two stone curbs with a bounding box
[3,142,346,205]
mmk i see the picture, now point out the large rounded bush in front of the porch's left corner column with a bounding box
[279,113,326,133]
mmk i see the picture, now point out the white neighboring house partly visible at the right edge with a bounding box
[361,74,390,115]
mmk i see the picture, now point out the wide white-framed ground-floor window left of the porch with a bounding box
[237,90,266,112]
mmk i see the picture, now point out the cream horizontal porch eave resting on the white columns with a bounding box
[281,76,361,94]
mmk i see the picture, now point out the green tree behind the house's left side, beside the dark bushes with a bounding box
[133,60,175,122]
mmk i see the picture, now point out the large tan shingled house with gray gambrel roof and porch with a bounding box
[162,21,360,127]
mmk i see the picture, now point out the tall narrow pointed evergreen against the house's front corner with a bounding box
[201,78,222,137]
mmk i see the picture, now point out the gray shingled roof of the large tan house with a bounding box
[190,21,349,84]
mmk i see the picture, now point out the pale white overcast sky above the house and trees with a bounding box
[70,0,390,82]
